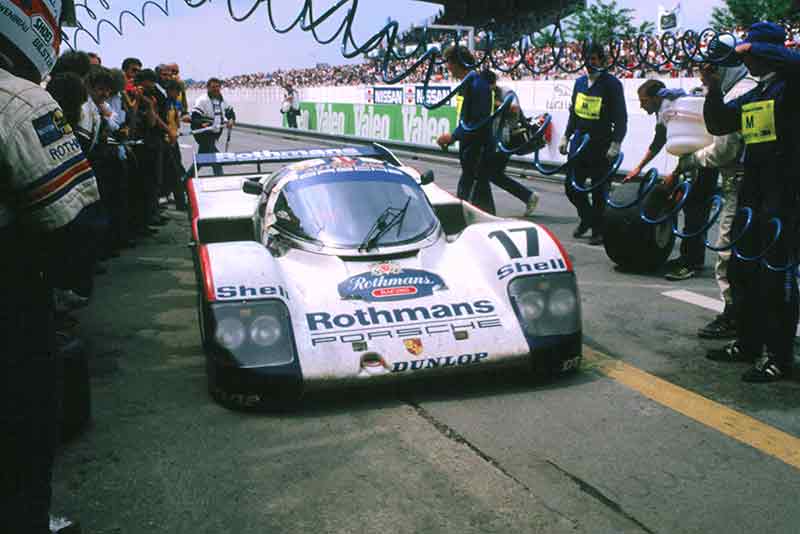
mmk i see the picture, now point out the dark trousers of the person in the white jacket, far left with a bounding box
[0,277,60,534]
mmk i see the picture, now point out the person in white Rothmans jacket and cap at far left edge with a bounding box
[0,0,98,534]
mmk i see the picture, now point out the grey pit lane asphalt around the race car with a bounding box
[54,130,800,534]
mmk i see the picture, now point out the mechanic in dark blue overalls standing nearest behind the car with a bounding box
[436,45,494,213]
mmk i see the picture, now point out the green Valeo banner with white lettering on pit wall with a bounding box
[283,102,456,145]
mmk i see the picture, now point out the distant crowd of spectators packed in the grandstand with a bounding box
[186,26,800,88]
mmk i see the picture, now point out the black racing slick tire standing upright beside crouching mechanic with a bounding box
[603,182,675,272]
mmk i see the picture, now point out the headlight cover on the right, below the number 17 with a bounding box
[508,272,581,336]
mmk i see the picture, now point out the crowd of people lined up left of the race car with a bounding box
[46,51,189,322]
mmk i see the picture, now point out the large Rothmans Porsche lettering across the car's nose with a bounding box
[306,300,503,347]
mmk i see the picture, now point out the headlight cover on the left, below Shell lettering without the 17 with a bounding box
[211,300,295,367]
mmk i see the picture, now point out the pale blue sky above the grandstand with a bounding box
[68,0,723,80]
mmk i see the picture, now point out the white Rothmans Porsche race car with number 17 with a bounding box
[187,145,582,408]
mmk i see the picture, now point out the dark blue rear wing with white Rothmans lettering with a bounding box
[195,143,402,172]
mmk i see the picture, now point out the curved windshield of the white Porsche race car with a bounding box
[274,168,436,249]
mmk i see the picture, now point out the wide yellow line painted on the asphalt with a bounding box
[583,345,800,469]
